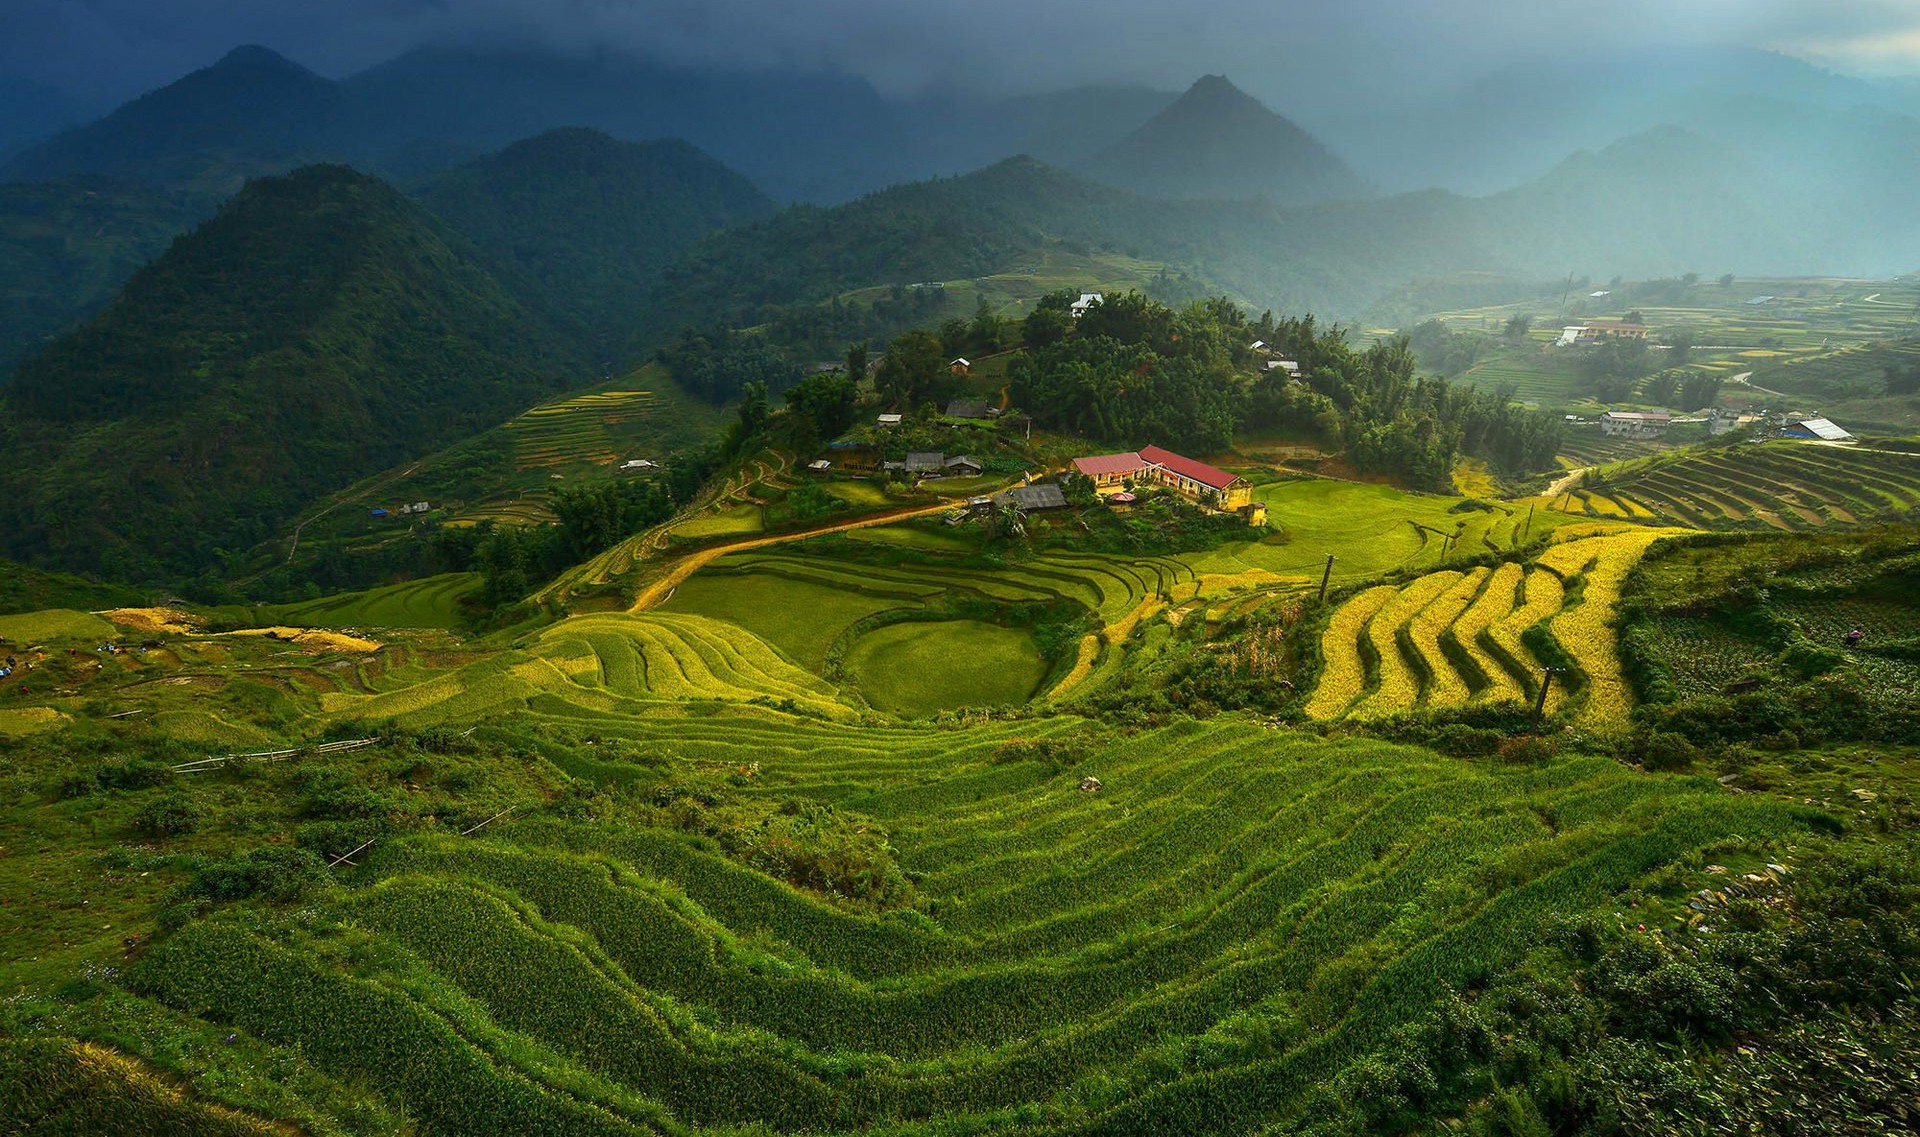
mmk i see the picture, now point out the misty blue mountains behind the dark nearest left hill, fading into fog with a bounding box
[0,33,1920,387]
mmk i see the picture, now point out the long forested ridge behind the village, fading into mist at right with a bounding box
[637,131,1889,346]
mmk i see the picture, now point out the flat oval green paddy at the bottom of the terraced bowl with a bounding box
[847,620,1046,716]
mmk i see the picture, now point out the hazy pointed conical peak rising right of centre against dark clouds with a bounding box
[1077,75,1369,206]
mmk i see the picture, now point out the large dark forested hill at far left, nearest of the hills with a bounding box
[0,167,584,580]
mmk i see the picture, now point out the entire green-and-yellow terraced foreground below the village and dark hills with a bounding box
[0,457,1920,1137]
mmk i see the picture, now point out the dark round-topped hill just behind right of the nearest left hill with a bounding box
[417,129,774,355]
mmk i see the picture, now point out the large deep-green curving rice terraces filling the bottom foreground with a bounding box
[127,713,1807,1137]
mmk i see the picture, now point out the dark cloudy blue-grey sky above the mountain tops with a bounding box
[0,0,1920,110]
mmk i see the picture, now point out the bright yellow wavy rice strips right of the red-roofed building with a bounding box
[1308,528,1678,730]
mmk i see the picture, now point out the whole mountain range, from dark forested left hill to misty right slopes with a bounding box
[0,38,1920,580]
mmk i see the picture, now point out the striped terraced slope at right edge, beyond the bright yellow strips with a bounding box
[1565,442,1920,530]
